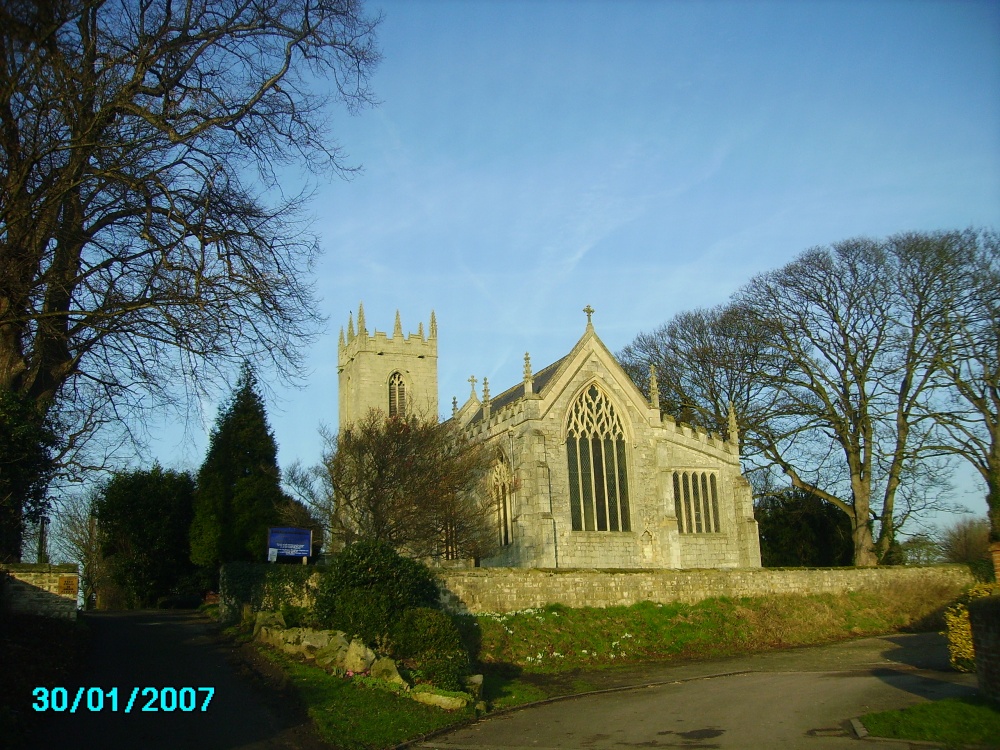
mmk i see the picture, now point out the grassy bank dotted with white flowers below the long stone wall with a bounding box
[465,586,955,673]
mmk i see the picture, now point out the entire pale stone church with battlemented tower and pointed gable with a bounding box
[338,306,760,568]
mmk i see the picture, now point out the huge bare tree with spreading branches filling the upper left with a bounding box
[0,0,378,470]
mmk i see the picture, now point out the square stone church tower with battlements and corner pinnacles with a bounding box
[337,304,438,432]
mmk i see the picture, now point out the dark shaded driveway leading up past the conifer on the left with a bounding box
[28,610,327,750]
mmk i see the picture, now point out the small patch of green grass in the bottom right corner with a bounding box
[861,698,1000,748]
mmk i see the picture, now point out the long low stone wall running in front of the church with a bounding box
[435,565,975,614]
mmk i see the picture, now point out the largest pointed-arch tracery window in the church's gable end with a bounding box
[566,385,631,531]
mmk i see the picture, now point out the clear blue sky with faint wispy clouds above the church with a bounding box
[148,0,1000,509]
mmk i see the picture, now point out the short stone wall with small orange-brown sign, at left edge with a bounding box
[0,563,80,618]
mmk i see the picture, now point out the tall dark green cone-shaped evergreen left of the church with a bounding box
[191,366,289,568]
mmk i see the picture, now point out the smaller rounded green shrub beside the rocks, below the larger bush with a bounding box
[392,607,469,690]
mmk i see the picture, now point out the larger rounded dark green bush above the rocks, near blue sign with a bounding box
[315,542,439,646]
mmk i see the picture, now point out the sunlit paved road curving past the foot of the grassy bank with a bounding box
[418,634,976,750]
